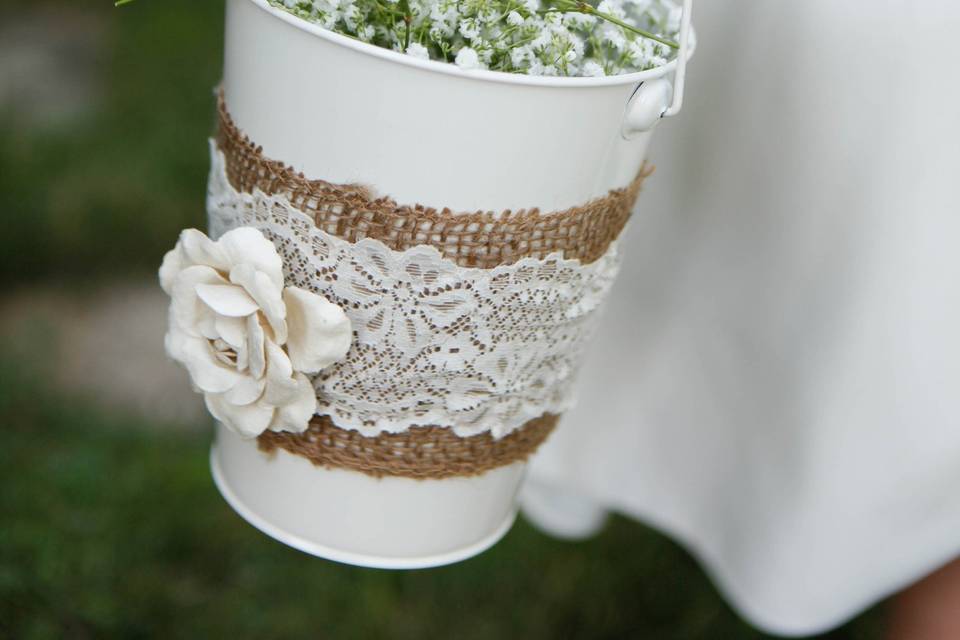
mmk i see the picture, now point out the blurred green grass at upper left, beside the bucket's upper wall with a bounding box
[0,0,223,284]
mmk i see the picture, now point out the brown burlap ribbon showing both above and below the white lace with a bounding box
[217,92,653,478]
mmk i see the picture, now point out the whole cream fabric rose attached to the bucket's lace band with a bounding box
[160,227,352,438]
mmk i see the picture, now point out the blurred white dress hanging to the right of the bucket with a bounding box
[523,0,960,634]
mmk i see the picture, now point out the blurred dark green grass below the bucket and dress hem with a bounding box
[0,346,881,640]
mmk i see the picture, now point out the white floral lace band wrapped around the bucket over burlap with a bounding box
[207,141,619,438]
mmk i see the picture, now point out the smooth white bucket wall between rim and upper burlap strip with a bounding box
[224,0,650,211]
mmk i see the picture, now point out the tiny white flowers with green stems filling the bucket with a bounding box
[269,0,680,76]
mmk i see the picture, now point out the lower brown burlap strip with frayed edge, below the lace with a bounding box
[257,414,560,479]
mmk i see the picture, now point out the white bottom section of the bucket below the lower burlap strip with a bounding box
[210,425,526,569]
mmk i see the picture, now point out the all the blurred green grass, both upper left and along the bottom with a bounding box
[0,0,882,640]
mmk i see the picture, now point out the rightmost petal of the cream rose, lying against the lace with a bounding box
[283,287,353,373]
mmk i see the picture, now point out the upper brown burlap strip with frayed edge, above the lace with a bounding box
[217,91,653,269]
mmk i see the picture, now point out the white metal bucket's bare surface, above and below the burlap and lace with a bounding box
[211,0,692,568]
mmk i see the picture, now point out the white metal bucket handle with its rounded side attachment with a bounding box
[620,0,693,140]
